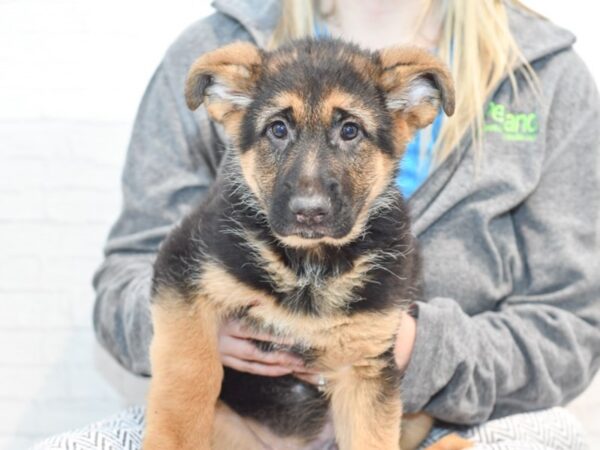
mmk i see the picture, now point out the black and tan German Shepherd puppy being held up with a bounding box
[144,40,466,450]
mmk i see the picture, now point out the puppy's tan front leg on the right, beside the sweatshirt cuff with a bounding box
[328,358,402,450]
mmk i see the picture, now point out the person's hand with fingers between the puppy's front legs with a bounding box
[218,320,318,384]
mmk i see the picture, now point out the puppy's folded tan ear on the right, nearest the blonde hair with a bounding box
[379,47,454,130]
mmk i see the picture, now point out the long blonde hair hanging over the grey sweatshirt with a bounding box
[270,0,538,164]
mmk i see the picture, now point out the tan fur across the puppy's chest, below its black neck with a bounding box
[198,250,401,370]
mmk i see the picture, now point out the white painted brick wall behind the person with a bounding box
[0,0,600,450]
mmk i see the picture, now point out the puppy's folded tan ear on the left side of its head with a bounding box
[185,42,262,122]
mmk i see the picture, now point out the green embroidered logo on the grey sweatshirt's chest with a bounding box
[483,102,539,142]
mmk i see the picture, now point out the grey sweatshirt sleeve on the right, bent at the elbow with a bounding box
[402,57,600,425]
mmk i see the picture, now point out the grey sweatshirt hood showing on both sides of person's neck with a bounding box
[213,0,575,63]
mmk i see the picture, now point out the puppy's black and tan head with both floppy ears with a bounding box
[186,40,454,247]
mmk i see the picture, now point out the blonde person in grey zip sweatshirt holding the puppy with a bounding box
[37,0,600,448]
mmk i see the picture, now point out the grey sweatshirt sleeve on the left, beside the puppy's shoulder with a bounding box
[94,62,215,375]
